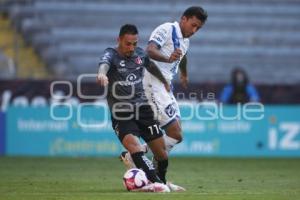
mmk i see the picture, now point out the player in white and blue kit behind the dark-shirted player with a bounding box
[123,6,207,191]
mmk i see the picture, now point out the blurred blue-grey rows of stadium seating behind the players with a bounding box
[5,0,300,84]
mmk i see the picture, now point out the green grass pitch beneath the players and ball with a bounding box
[0,157,300,200]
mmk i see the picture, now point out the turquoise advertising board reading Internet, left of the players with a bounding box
[7,107,122,156]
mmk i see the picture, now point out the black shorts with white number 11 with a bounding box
[112,105,163,143]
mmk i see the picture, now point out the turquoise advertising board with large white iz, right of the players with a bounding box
[172,105,300,157]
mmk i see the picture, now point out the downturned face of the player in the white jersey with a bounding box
[180,16,203,38]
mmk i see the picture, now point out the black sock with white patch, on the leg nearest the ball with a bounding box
[131,152,162,183]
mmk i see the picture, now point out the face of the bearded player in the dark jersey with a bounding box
[118,34,138,57]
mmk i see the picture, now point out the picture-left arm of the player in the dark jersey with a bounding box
[96,48,112,86]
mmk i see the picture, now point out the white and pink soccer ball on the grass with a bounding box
[123,168,149,191]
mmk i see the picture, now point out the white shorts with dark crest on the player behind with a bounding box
[143,70,180,128]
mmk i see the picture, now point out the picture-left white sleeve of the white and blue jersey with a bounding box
[148,24,171,48]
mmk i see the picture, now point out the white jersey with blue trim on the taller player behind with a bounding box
[149,21,190,82]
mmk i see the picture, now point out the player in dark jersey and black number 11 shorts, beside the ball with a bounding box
[97,24,170,192]
